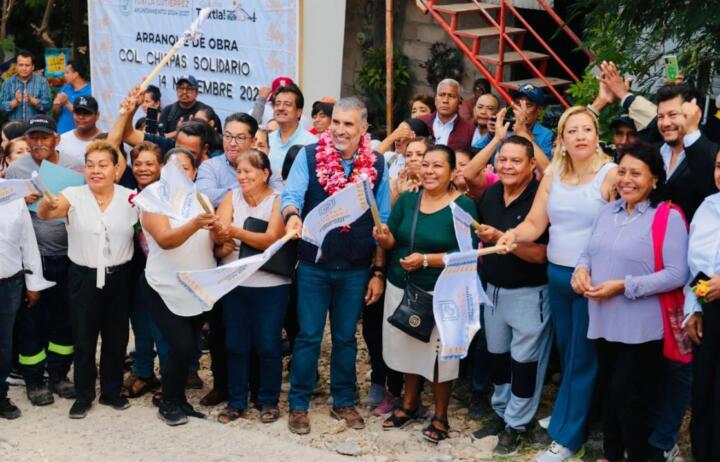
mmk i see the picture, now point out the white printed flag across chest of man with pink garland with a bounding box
[302,179,374,262]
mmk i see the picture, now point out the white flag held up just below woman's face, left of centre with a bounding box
[132,156,197,220]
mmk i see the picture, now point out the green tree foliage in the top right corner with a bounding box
[573,0,720,91]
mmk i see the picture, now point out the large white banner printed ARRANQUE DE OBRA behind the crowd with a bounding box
[88,0,300,128]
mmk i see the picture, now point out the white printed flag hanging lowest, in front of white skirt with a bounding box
[433,250,491,361]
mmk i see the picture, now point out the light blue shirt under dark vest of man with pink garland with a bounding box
[280,148,390,223]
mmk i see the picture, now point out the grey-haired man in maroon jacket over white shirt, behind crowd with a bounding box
[420,79,475,150]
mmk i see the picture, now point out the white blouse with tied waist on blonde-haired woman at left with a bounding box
[62,185,138,288]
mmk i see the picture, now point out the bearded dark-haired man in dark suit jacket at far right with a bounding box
[656,84,718,221]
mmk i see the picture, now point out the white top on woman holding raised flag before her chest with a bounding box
[145,191,217,316]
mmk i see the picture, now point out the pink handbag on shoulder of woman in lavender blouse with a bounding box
[652,202,692,364]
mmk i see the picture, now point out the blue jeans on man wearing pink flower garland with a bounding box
[288,262,370,411]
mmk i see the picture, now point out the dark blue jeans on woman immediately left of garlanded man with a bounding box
[223,285,290,409]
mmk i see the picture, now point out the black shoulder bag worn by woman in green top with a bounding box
[387,190,435,343]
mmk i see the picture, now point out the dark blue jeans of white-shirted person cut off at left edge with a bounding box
[0,276,23,398]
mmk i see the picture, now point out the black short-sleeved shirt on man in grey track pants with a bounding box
[477,178,548,289]
